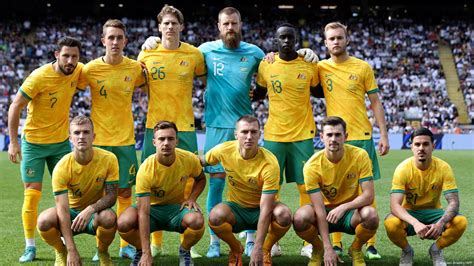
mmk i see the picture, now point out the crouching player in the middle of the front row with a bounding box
[206,115,291,265]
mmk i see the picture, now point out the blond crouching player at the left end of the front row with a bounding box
[38,116,118,265]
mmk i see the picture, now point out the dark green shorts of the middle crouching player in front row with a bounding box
[222,201,260,233]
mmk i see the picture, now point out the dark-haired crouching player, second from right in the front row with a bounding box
[293,116,379,266]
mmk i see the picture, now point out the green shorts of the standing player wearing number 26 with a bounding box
[141,128,198,162]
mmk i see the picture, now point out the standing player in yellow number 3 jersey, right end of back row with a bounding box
[314,22,390,259]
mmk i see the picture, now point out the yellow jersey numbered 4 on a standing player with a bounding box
[79,57,145,146]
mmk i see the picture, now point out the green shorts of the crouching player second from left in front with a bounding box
[132,204,196,233]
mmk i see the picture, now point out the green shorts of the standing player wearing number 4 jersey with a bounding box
[95,145,138,188]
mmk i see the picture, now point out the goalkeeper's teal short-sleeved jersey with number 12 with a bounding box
[199,40,265,128]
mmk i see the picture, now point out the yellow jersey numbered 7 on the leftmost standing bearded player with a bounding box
[20,63,84,144]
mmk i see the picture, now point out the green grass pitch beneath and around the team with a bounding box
[0,150,474,265]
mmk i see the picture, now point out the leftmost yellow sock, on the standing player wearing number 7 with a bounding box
[21,189,41,239]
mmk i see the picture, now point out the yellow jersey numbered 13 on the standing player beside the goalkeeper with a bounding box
[257,55,319,142]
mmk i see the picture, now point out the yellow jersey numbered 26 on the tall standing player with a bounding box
[138,42,206,131]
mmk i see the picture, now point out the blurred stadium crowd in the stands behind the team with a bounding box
[0,18,474,138]
